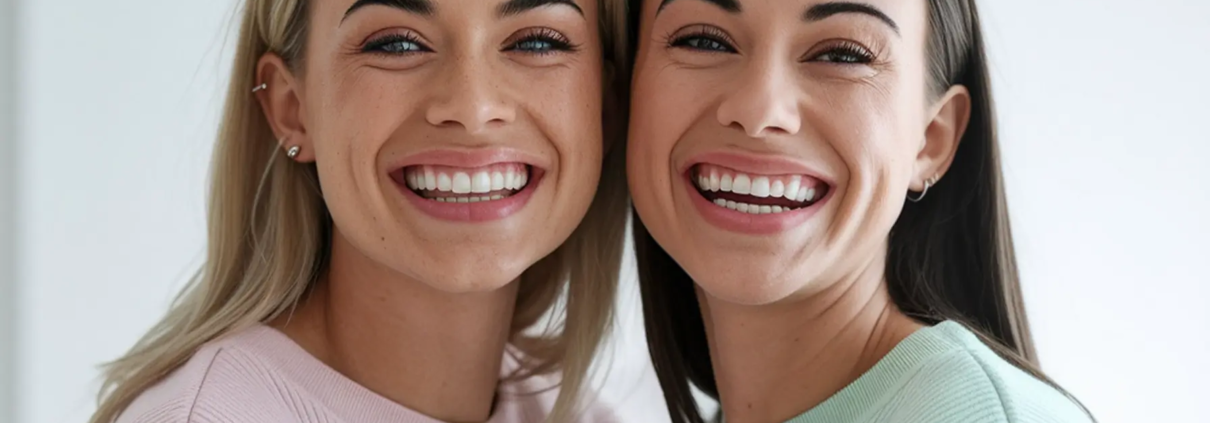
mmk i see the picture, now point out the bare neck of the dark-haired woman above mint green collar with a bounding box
[698,255,920,423]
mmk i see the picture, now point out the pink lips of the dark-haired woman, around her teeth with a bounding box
[680,152,836,234]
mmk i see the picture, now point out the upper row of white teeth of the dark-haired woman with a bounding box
[695,164,816,202]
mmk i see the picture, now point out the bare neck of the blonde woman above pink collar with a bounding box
[273,231,518,422]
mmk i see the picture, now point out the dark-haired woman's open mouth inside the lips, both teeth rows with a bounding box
[688,163,829,214]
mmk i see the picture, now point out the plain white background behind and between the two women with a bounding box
[0,0,1210,423]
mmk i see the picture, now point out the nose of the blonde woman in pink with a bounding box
[425,54,517,133]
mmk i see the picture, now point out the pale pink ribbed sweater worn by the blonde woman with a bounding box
[117,325,617,423]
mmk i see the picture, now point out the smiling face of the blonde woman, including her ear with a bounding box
[260,0,603,292]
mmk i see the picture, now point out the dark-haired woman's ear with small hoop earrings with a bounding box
[910,86,970,191]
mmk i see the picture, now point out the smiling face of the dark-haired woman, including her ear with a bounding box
[628,0,966,305]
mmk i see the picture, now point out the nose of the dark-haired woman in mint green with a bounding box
[718,58,802,138]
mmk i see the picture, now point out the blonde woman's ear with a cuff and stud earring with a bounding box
[255,53,315,162]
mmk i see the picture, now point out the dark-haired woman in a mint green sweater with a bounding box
[628,0,1091,423]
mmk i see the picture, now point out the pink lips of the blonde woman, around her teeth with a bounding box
[391,149,546,222]
